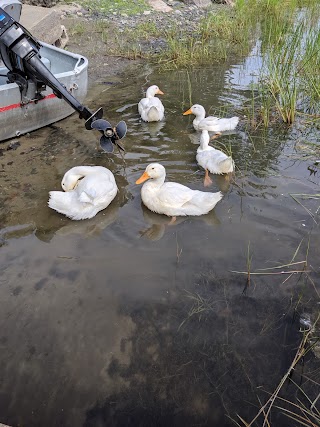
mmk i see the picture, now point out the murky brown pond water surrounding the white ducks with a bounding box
[0,54,320,427]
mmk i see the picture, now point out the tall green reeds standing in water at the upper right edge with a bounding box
[246,0,320,127]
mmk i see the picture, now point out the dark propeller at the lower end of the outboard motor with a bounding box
[91,119,127,153]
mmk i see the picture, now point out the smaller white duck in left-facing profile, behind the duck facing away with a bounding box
[183,104,239,139]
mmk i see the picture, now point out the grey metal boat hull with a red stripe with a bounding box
[0,43,88,141]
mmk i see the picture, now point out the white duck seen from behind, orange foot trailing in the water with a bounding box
[196,130,234,187]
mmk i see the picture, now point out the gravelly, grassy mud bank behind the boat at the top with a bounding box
[59,1,228,83]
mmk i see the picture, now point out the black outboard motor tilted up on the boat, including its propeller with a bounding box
[0,0,127,152]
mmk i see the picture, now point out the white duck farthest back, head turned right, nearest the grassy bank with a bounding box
[138,85,164,122]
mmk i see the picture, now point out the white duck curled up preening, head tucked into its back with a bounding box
[48,166,118,220]
